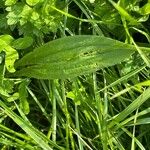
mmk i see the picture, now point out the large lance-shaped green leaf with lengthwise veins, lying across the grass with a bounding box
[14,35,150,79]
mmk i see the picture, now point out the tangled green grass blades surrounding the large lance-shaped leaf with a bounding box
[0,0,150,150]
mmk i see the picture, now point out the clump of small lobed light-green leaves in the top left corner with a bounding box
[3,0,63,36]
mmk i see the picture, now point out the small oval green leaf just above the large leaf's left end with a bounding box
[12,36,33,49]
